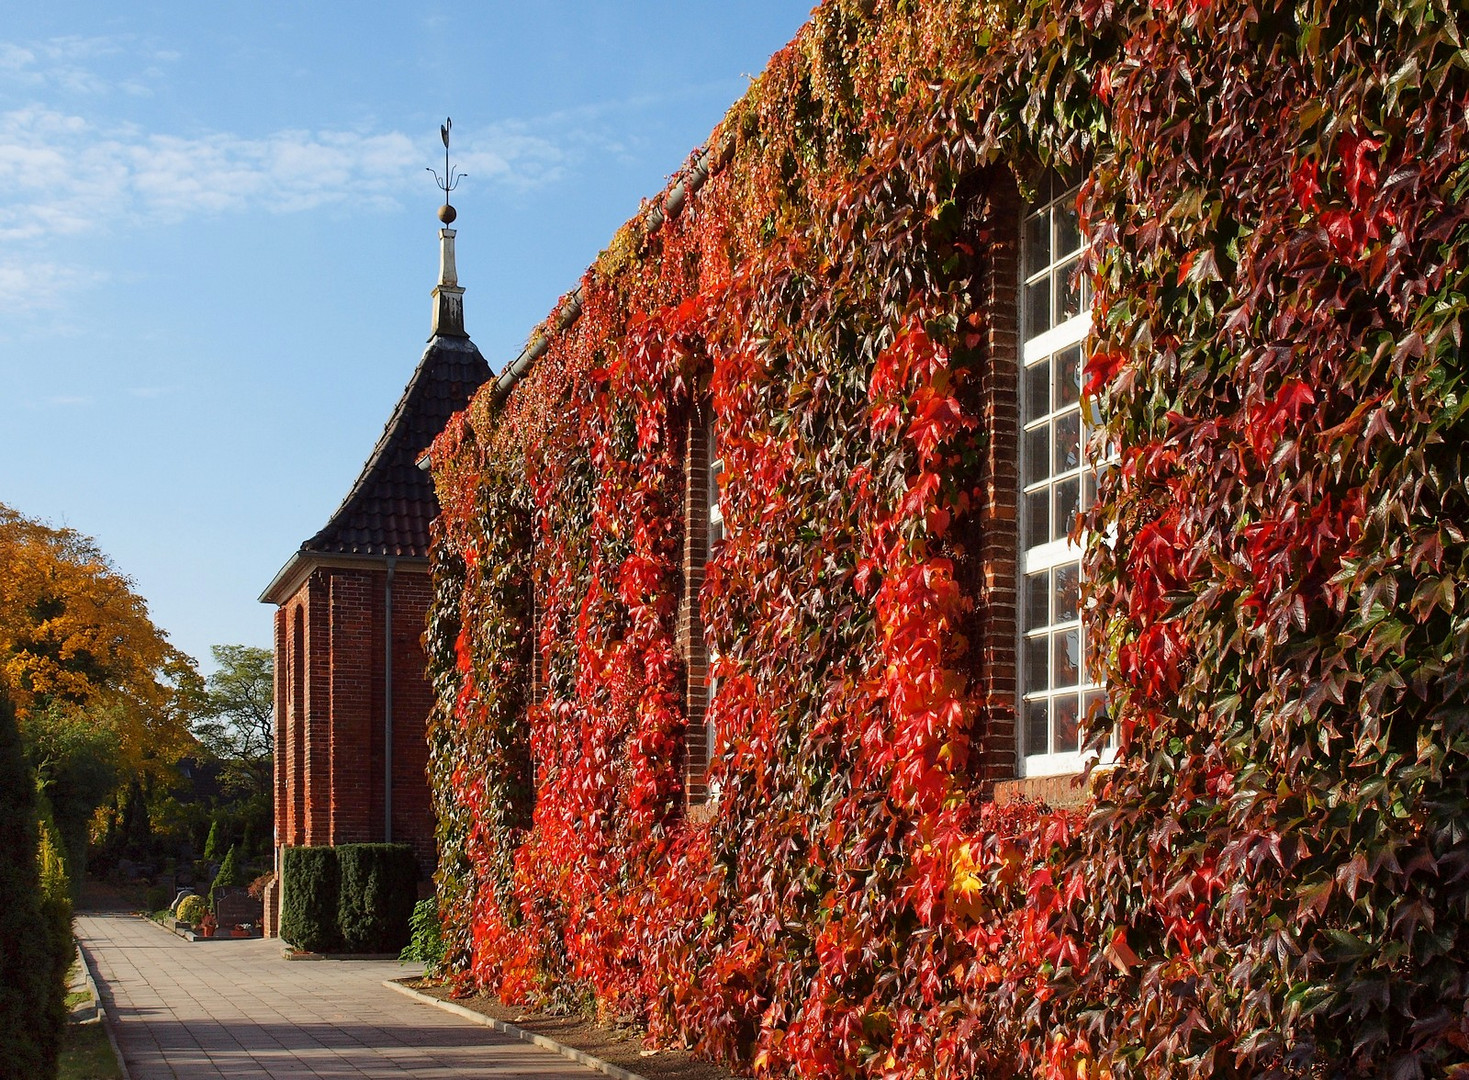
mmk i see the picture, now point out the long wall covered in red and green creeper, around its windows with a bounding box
[426,0,1469,1077]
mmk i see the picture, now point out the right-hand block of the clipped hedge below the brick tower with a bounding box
[336,843,419,952]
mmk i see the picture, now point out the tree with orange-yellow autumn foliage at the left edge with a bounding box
[0,504,203,875]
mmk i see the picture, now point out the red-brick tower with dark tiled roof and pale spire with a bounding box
[260,213,489,935]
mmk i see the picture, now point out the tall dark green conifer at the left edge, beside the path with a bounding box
[0,691,62,1080]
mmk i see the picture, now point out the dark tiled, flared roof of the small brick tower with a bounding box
[301,336,489,555]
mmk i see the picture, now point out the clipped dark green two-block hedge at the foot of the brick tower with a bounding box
[281,843,419,952]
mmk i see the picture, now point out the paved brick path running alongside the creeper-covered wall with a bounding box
[76,914,605,1080]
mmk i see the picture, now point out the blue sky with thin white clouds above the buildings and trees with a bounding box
[0,0,811,669]
